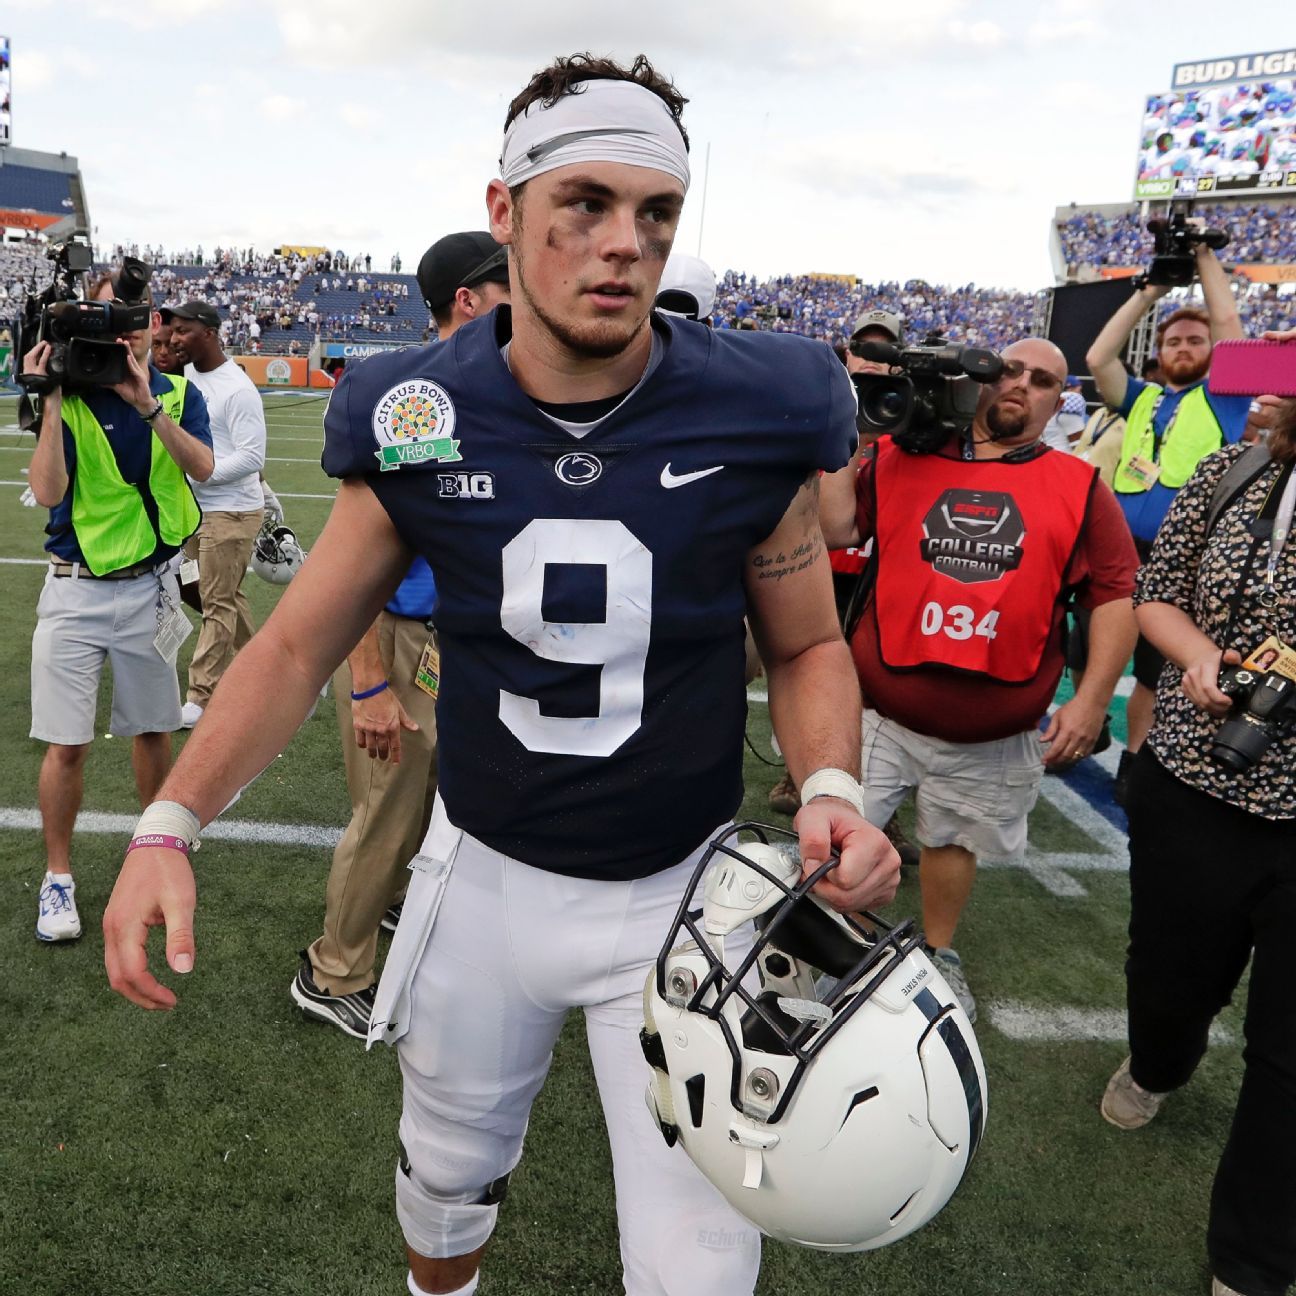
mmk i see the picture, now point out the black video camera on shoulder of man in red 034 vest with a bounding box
[850,337,1003,455]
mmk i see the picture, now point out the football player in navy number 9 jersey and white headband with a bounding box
[105,56,898,1296]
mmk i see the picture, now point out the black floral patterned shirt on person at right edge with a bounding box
[1134,446,1296,819]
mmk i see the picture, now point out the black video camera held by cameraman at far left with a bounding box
[14,238,153,395]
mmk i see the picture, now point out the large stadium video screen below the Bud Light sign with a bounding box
[1134,78,1296,198]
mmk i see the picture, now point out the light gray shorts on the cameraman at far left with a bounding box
[31,572,180,746]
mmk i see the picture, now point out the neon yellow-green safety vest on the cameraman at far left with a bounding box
[64,376,202,575]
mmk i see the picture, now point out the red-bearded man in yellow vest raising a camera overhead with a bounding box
[1086,222,1249,804]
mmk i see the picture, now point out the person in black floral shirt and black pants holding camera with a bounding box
[1102,330,1296,1296]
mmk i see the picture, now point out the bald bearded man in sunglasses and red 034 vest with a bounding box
[819,338,1138,1021]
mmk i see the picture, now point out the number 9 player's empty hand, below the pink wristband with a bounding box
[104,846,196,1008]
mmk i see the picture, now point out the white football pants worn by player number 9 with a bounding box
[375,798,761,1296]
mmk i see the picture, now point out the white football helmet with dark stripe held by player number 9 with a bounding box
[642,824,986,1251]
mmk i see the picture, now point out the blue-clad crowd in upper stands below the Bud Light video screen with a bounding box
[1058,202,1296,273]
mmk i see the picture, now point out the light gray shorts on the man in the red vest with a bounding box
[861,708,1043,861]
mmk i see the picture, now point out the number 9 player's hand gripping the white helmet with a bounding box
[792,797,899,914]
